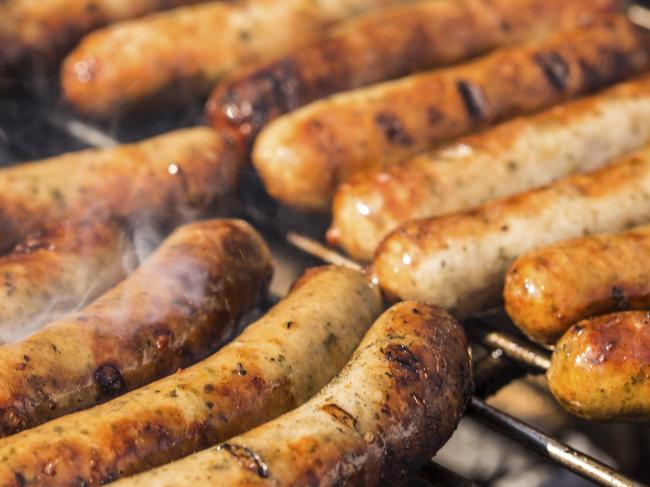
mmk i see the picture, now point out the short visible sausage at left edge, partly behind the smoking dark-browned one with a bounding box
[0,220,134,343]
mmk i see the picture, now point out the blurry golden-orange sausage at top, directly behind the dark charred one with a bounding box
[61,0,399,118]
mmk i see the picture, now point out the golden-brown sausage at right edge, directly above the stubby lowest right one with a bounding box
[503,226,650,344]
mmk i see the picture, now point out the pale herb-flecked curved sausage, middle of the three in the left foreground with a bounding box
[0,266,382,487]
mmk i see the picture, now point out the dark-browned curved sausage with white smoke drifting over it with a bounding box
[0,220,272,436]
